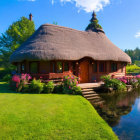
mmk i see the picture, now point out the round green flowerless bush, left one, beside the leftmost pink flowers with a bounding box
[30,79,44,94]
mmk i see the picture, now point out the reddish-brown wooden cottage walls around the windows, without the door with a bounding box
[16,60,126,82]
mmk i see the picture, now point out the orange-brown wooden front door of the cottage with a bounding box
[80,61,89,83]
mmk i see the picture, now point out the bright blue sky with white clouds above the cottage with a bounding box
[0,0,140,50]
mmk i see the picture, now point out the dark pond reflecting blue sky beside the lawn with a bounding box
[91,89,140,140]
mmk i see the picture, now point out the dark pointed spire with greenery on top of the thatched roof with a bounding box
[86,12,102,31]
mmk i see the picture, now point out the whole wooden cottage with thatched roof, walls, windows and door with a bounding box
[10,14,131,83]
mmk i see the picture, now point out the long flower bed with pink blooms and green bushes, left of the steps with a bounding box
[11,74,81,94]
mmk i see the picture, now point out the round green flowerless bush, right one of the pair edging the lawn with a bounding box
[43,81,54,93]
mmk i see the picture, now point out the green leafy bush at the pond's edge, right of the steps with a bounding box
[101,75,126,91]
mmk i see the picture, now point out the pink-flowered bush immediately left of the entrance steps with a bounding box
[63,76,81,94]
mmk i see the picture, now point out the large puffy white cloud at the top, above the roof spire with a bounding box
[52,0,110,12]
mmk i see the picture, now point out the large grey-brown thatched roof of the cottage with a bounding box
[10,24,131,63]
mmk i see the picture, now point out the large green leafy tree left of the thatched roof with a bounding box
[0,17,35,69]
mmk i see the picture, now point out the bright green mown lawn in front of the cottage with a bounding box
[0,82,118,140]
